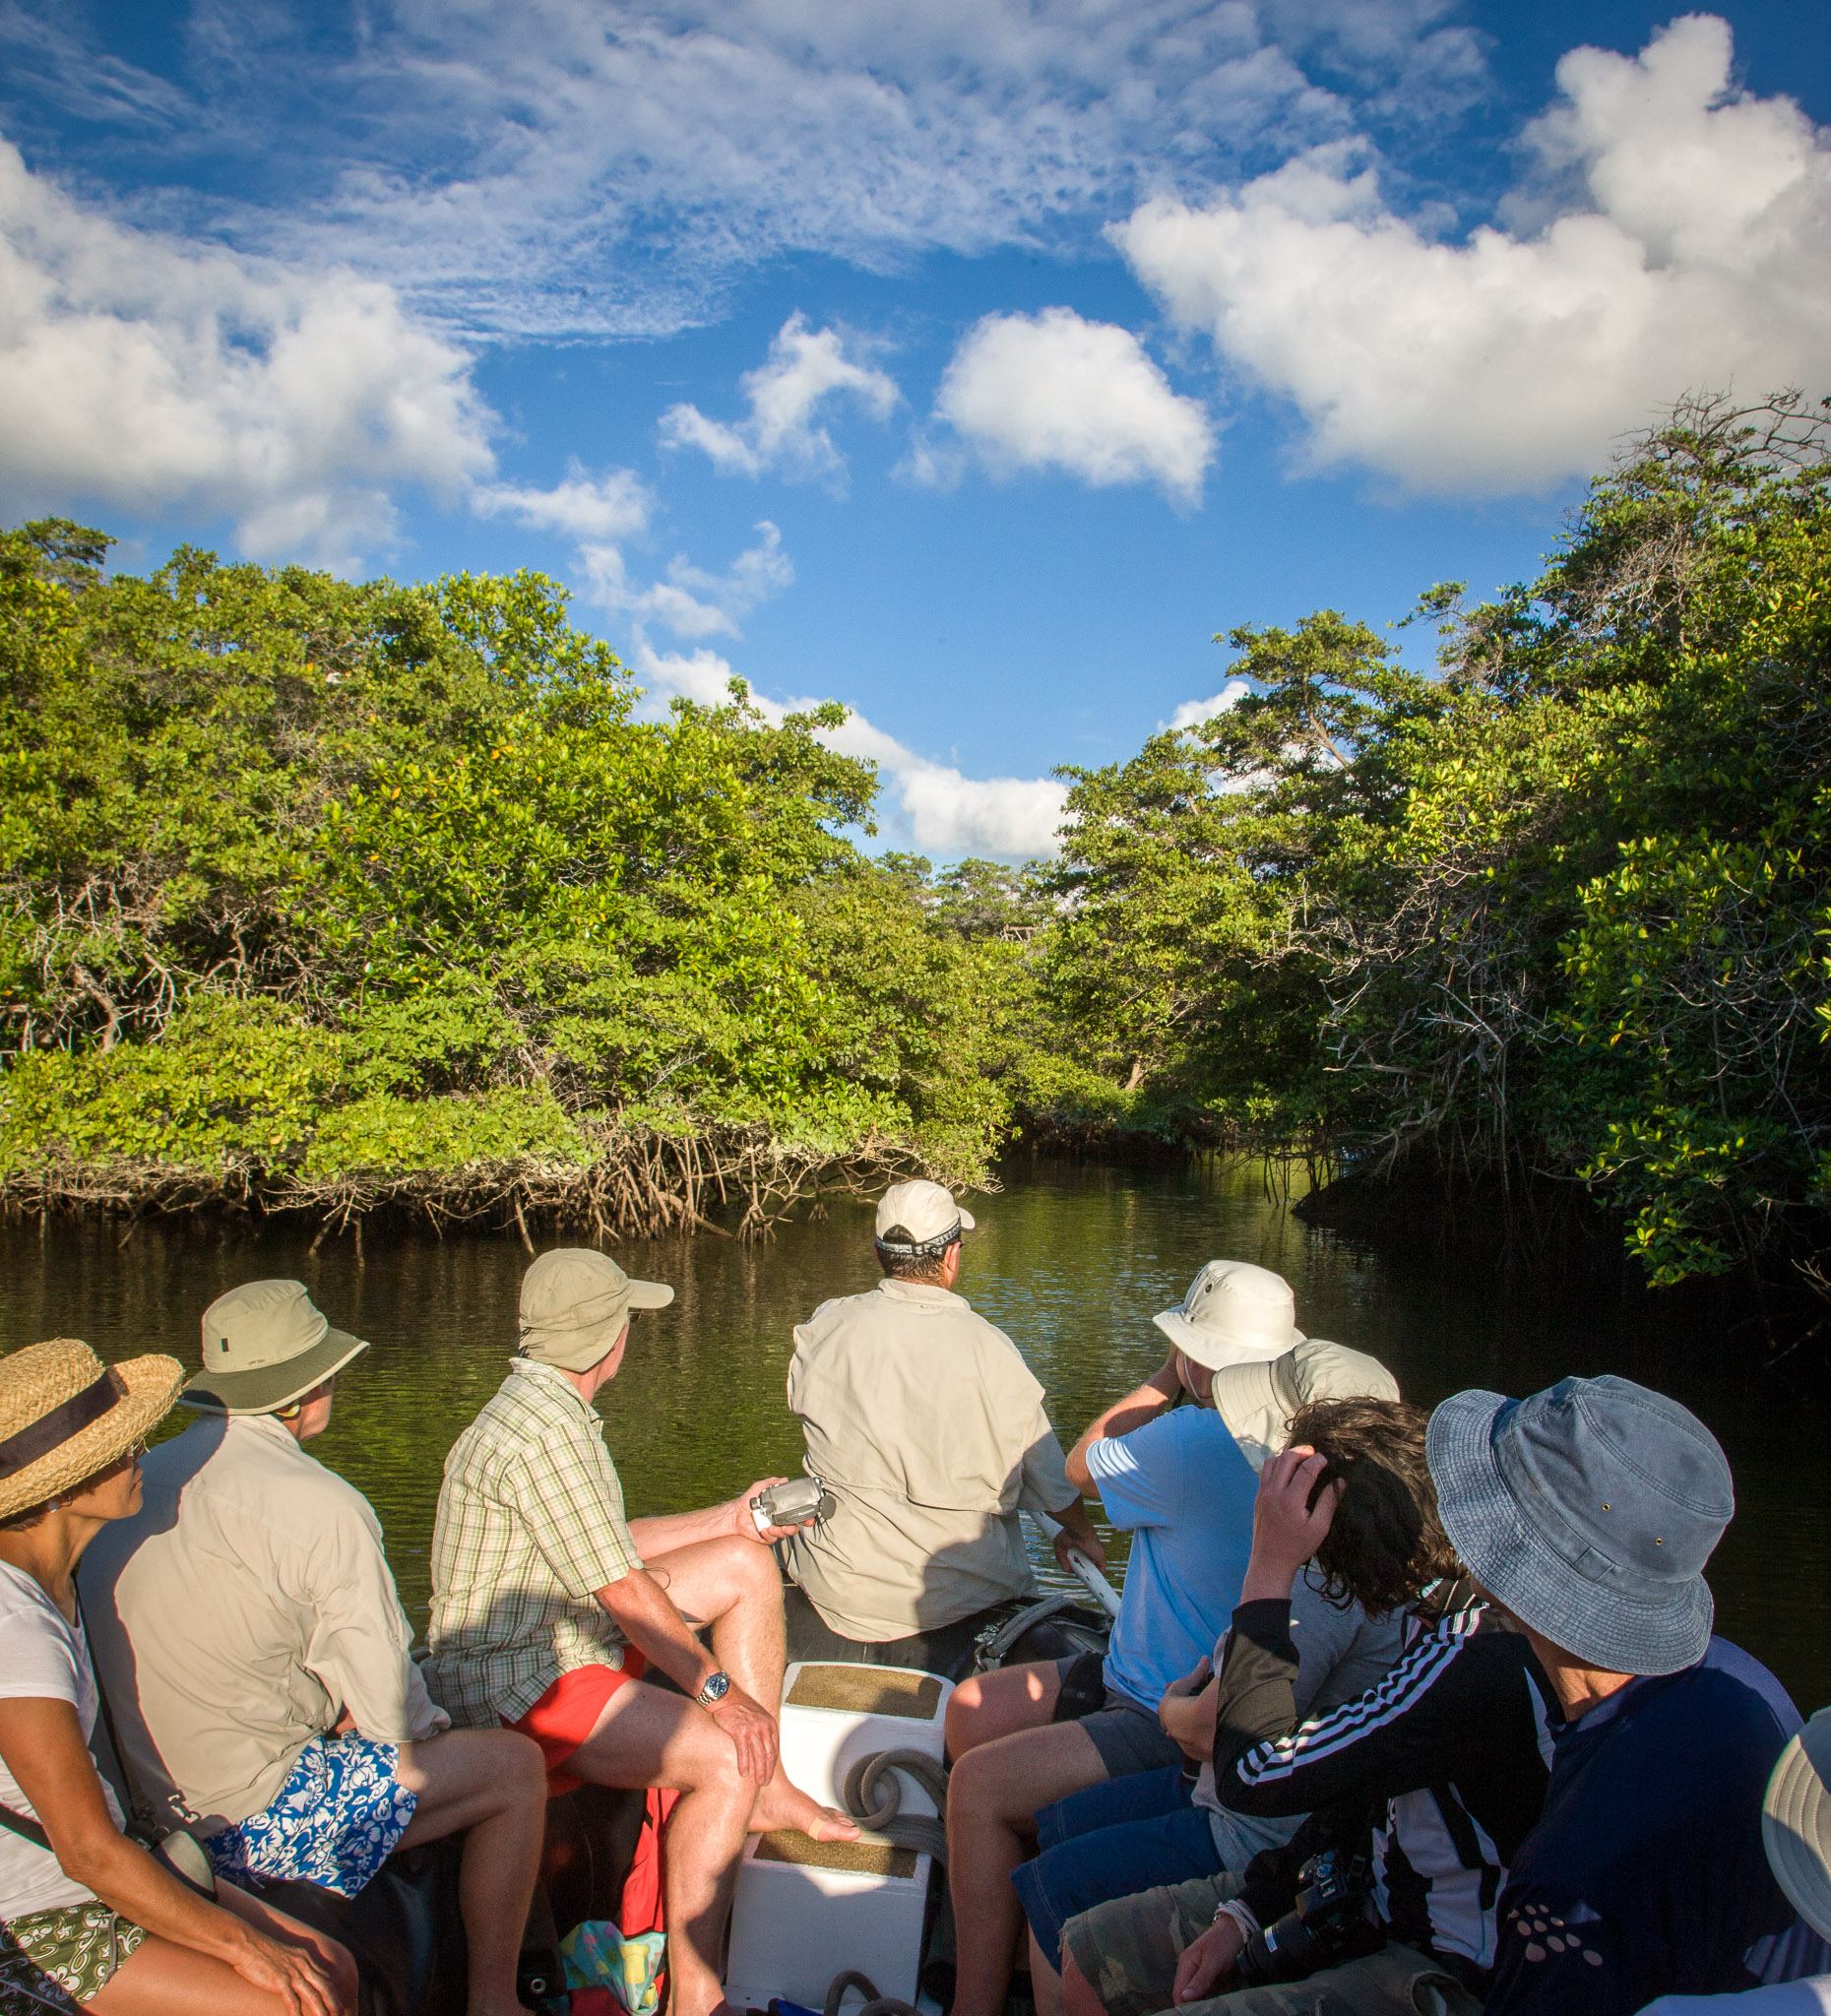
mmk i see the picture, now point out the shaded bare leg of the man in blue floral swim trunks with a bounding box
[400,1730,546,2016]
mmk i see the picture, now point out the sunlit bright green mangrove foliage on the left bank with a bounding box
[0,520,1008,1183]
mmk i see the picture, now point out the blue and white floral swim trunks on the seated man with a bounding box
[204,1735,417,1897]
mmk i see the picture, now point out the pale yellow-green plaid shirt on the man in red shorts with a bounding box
[425,1358,641,1728]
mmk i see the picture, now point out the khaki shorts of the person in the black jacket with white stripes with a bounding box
[1063,1875,1481,2016]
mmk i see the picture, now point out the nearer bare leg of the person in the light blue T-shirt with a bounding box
[948,1717,1107,2016]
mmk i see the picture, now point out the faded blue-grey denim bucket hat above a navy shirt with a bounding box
[1425,1373,1736,1673]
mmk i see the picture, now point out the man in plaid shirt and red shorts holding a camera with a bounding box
[427,1246,857,2016]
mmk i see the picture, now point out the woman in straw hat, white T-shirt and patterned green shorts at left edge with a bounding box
[0,1337,357,2016]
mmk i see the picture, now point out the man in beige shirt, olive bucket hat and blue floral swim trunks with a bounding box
[81,1280,546,2016]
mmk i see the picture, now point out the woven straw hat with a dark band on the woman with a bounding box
[0,1337,183,1518]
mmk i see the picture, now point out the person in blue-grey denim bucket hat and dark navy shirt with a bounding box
[1429,1375,1800,2016]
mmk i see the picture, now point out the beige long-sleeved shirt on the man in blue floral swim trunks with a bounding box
[81,1416,450,1835]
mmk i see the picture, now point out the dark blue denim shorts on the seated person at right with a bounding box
[1010,1764,1220,1966]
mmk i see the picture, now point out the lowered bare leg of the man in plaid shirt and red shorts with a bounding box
[567,1679,774,2016]
